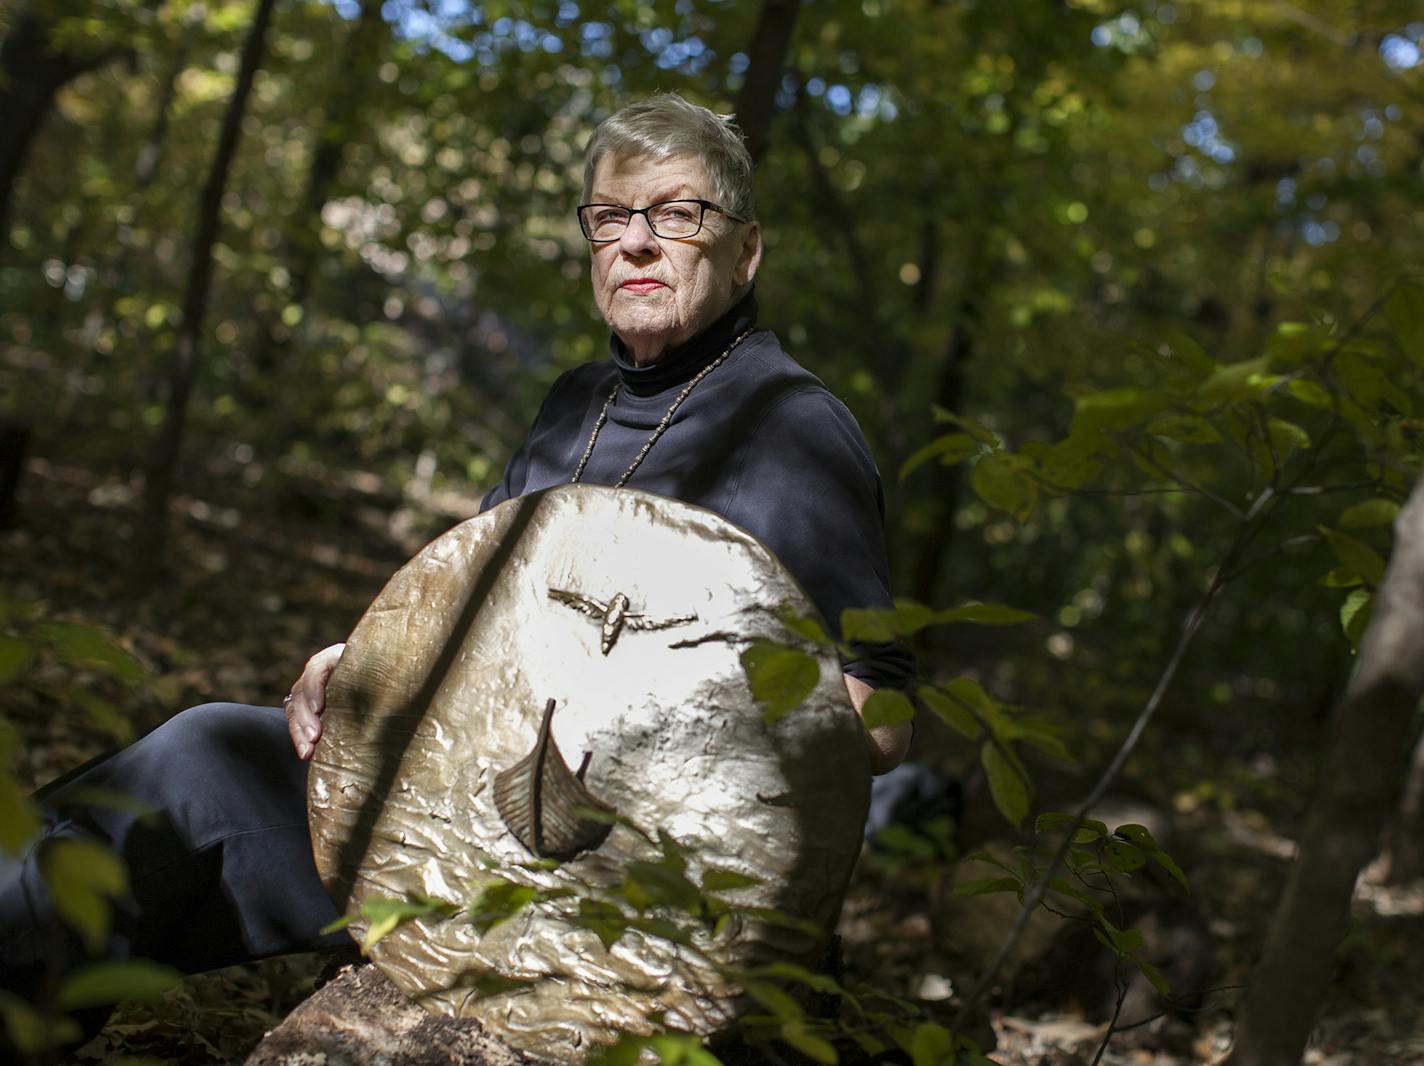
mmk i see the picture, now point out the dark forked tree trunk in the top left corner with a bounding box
[0,11,122,249]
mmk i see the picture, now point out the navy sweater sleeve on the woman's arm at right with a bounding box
[728,386,914,687]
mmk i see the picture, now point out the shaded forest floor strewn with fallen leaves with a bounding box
[0,458,1424,1066]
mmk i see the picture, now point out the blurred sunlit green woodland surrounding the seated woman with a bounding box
[0,0,1424,1063]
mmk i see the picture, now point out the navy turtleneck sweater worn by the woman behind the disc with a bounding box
[480,293,911,685]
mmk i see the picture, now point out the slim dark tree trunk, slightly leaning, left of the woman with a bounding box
[134,0,276,585]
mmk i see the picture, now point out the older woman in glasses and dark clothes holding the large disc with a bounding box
[0,95,909,993]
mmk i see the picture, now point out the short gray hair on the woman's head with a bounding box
[584,93,756,219]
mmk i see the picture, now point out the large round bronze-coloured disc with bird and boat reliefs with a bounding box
[308,485,869,1062]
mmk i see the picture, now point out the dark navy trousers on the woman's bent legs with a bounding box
[0,703,350,999]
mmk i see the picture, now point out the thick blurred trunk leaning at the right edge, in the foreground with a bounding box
[1227,477,1424,1066]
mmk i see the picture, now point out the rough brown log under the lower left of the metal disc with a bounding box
[246,966,528,1066]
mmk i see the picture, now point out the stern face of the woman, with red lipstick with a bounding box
[590,155,762,366]
